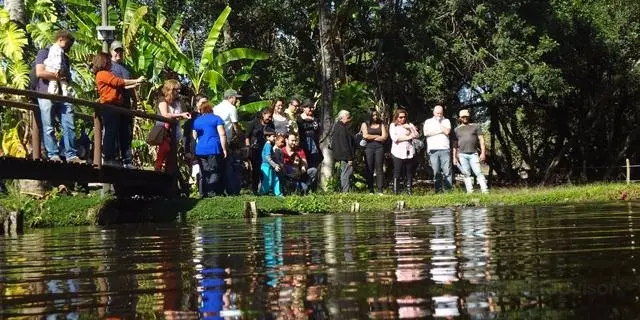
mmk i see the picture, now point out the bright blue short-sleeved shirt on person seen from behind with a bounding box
[193,113,224,156]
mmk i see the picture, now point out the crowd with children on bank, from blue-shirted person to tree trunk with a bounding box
[188,94,321,197]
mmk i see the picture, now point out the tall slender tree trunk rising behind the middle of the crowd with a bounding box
[318,0,335,190]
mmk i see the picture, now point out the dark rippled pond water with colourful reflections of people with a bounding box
[0,203,640,319]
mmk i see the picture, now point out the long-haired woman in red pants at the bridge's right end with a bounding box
[153,79,191,172]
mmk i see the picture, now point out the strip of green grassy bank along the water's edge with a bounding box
[0,184,640,227]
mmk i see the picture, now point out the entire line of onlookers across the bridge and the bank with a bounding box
[34,30,488,197]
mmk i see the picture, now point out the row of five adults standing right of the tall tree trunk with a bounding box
[332,105,488,195]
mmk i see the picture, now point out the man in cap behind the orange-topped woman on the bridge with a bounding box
[111,41,138,168]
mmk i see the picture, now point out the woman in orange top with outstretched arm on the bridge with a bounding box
[92,52,144,166]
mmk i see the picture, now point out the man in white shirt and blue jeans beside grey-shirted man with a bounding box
[423,106,453,193]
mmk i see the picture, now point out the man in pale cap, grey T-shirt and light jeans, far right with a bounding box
[453,109,489,193]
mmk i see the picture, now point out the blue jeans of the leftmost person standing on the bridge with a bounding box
[38,99,76,159]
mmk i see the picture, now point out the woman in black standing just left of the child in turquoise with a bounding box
[244,108,275,194]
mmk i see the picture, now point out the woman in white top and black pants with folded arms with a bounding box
[389,108,420,195]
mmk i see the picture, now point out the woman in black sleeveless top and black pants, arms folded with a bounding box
[357,109,389,194]
